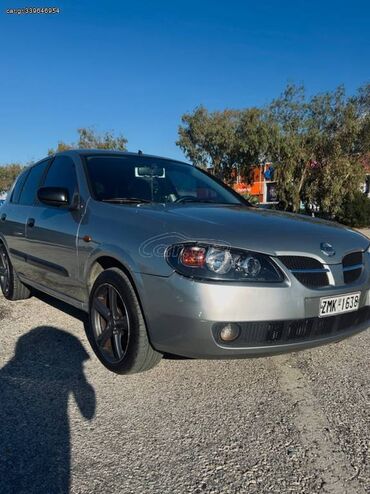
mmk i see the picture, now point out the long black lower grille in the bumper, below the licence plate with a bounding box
[213,306,370,347]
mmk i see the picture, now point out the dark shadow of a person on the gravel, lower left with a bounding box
[0,326,96,494]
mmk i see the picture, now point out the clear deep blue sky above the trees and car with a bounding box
[0,0,370,163]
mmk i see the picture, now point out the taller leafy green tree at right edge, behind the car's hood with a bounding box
[268,86,368,217]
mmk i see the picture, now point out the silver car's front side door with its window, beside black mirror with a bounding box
[26,155,82,301]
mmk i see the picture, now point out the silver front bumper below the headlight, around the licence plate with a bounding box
[140,273,370,358]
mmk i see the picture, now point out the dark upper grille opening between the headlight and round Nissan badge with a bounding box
[279,256,329,288]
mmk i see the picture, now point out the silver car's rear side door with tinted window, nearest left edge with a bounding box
[0,160,50,278]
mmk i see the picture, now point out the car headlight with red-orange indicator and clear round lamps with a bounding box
[166,243,284,283]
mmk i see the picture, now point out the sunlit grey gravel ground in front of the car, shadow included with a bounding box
[0,298,370,494]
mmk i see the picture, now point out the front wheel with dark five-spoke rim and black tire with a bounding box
[85,268,162,374]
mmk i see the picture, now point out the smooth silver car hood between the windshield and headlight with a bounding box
[158,204,369,264]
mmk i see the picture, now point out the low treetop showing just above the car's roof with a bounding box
[48,127,127,155]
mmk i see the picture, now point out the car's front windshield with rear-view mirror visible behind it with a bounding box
[86,155,243,204]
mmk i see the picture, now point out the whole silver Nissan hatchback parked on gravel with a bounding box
[0,150,370,373]
